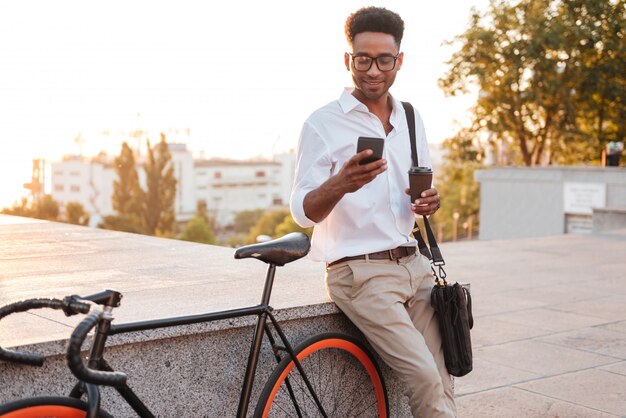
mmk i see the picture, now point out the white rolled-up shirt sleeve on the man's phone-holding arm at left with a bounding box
[289,121,332,228]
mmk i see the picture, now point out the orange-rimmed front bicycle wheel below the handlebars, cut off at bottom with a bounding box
[0,396,113,418]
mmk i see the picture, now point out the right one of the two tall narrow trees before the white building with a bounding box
[143,133,176,236]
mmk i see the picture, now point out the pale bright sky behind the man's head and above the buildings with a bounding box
[0,0,488,207]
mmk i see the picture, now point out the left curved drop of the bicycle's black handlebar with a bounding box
[0,297,90,367]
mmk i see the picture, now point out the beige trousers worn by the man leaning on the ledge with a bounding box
[326,253,456,418]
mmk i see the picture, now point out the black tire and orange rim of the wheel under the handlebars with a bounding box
[0,396,113,418]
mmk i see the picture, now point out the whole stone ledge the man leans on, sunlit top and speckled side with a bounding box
[0,215,410,417]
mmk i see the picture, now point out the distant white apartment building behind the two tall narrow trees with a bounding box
[51,143,295,226]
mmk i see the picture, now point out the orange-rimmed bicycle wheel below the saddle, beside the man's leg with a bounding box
[254,333,389,418]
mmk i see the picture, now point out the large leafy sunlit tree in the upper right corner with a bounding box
[439,0,626,166]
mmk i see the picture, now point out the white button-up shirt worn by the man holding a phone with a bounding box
[290,89,432,262]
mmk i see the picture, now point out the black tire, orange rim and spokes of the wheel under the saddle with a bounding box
[254,333,389,418]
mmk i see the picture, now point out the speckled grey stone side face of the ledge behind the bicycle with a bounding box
[0,311,410,417]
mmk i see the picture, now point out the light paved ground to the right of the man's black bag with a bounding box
[442,230,626,418]
